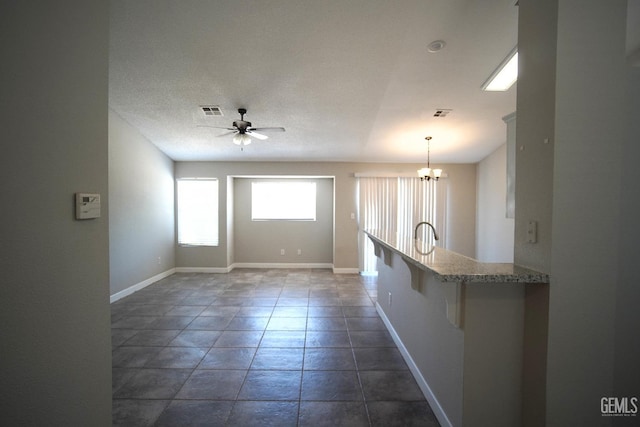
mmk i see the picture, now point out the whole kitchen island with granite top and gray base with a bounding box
[365,230,549,427]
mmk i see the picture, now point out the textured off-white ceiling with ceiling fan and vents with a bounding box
[109,0,518,163]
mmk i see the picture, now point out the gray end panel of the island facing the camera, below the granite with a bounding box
[462,283,525,427]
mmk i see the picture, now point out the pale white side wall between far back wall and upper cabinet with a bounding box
[476,144,514,262]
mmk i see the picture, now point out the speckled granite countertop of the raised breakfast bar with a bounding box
[365,230,549,283]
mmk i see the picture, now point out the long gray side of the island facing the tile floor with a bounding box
[377,252,464,426]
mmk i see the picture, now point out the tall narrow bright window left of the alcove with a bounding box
[177,179,218,246]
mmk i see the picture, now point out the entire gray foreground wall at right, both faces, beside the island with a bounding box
[515,0,640,426]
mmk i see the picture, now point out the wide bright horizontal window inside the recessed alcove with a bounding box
[251,181,316,221]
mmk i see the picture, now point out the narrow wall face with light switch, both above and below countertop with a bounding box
[514,0,557,426]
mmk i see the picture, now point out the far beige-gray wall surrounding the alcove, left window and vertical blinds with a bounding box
[175,162,476,270]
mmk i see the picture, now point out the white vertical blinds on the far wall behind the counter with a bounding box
[358,177,447,273]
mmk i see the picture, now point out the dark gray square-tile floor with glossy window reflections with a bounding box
[111,269,438,427]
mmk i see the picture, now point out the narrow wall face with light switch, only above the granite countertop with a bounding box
[514,0,557,272]
